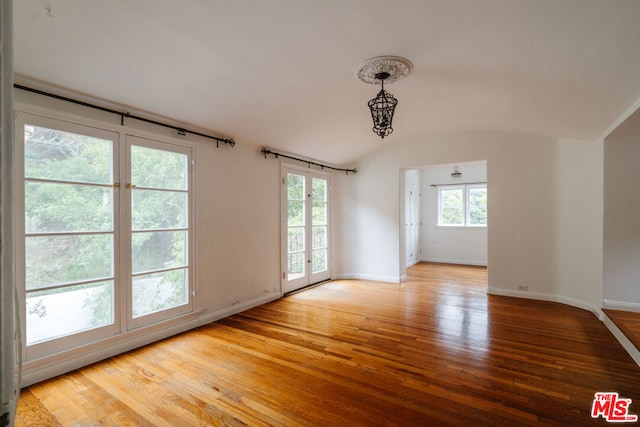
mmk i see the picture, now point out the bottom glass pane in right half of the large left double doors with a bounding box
[132,268,189,318]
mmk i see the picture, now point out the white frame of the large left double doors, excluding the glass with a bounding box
[14,109,198,364]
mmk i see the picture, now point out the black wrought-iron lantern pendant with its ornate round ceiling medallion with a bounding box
[358,56,413,139]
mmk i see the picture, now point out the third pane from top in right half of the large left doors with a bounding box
[131,231,187,274]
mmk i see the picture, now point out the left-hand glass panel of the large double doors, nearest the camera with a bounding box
[16,116,116,352]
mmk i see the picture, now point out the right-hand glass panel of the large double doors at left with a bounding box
[127,138,191,327]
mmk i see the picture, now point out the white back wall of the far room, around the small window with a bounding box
[421,162,490,265]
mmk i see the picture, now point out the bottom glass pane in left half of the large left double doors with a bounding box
[26,281,113,345]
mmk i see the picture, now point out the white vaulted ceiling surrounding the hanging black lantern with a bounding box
[14,0,640,164]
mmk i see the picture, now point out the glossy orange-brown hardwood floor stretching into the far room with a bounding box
[16,264,640,426]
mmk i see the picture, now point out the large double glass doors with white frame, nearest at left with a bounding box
[16,112,192,360]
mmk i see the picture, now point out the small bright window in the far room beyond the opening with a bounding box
[438,184,487,227]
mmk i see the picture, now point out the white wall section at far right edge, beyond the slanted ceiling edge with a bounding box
[604,110,640,312]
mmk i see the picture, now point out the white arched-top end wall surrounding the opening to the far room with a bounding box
[336,132,602,312]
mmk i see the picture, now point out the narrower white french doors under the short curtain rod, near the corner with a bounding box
[282,166,331,293]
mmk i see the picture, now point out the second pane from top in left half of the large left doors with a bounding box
[25,182,113,233]
